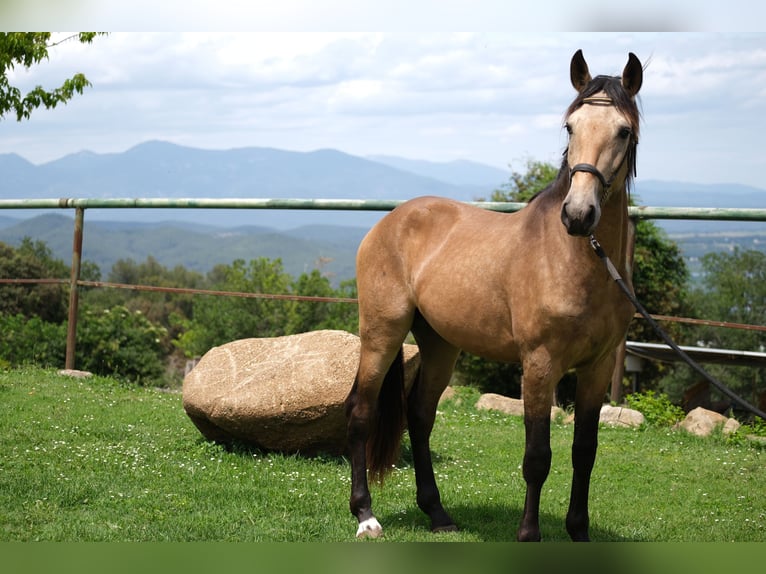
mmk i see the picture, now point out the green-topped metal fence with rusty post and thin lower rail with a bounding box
[0,198,766,378]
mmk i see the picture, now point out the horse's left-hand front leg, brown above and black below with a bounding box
[517,353,560,542]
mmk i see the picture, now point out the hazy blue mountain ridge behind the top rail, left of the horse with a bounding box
[0,141,502,229]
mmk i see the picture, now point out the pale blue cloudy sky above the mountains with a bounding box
[0,28,766,189]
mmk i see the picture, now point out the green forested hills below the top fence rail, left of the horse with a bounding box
[0,213,367,284]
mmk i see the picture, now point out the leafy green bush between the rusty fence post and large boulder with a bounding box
[76,306,167,384]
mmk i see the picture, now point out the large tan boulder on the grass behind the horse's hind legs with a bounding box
[183,331,420,454]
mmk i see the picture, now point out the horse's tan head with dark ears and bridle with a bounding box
[561,50,643,236]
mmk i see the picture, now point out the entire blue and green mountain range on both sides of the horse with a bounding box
[0,141,766,279]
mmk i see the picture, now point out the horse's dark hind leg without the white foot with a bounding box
[407,317,460,532]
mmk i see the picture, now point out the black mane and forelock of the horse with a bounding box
[529,76,641,203]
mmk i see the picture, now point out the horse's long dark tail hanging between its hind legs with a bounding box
[367,349,407,483]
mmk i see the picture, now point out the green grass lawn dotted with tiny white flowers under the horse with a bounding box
[0,369,766,542]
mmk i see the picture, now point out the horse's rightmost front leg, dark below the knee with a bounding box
[566,355,615,542]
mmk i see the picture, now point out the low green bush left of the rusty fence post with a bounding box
[0,313,66,367]
